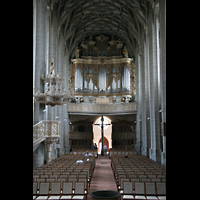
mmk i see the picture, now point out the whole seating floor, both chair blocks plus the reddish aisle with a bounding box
[33,150,166,200]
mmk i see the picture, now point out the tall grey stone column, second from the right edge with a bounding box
[148,6,161,162]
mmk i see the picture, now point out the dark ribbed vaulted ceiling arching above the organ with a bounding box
[48,0,158,60]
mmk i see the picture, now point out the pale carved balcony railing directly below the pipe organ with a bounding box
[68,102,137,114]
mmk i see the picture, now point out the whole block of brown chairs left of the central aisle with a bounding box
[33,152,95,199]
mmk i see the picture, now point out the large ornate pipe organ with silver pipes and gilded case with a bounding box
[69,35,136,103]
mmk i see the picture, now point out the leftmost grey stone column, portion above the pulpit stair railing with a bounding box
[33,0,47,124]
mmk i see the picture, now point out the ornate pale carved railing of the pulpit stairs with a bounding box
[33,120,60,142]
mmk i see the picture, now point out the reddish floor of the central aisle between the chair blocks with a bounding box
[87,156,117,200]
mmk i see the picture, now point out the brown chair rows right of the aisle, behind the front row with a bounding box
[111,155,166,193]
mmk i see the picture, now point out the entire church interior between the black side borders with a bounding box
[33,0,166,200]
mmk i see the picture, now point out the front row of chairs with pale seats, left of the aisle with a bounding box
[33,181,87,200]
